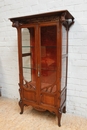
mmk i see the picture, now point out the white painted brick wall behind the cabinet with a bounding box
[0,0,87,117]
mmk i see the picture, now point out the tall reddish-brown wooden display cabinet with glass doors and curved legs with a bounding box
[10,10,74,126]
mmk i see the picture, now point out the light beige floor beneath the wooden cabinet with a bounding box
[0,97,87,130]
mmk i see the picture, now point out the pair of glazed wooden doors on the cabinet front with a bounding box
[21,23,58,106]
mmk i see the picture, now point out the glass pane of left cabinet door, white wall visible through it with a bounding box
[21,27,36,90]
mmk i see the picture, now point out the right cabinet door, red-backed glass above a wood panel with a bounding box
[39,24,57,106]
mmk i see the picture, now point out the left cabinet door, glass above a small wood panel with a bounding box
[21,27,37,102]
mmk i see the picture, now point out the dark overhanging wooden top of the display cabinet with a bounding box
[9,10,74,22]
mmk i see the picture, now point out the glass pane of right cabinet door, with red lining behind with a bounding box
[41,26,57,92]
